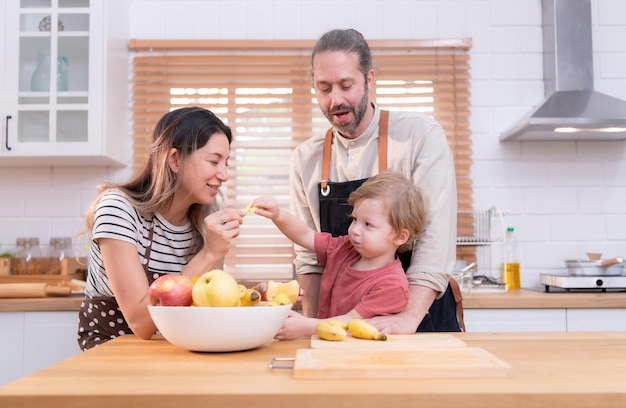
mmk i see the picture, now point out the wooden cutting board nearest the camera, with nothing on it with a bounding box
[293,347,512,379]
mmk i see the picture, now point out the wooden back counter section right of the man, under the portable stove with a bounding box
[463,289,626,309]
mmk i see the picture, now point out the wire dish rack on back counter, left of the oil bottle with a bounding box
[456,206,507,292]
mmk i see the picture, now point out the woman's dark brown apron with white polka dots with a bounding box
[78,222,162,351]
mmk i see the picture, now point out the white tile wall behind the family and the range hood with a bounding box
[0,0,626,286]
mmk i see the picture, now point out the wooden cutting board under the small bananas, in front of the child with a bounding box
[311,333,467,350]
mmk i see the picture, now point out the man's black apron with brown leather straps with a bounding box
[319,110,463,332]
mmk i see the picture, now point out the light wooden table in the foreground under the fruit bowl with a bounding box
[0,332,626,408]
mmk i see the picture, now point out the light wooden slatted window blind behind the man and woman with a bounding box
[130,40,472,280]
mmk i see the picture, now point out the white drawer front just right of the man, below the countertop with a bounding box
[463,309,567,332]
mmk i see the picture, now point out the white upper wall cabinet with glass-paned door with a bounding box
[0,0,132,166]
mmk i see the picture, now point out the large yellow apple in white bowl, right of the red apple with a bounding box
[191,269,240,307]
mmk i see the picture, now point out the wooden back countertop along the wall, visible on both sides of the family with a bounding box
[0,289,626,312]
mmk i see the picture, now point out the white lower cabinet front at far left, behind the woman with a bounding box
[0,311,81,385]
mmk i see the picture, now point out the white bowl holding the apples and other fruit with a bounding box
[148,302,292,352]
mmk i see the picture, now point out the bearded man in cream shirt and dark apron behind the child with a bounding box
[290,29,460,333]
